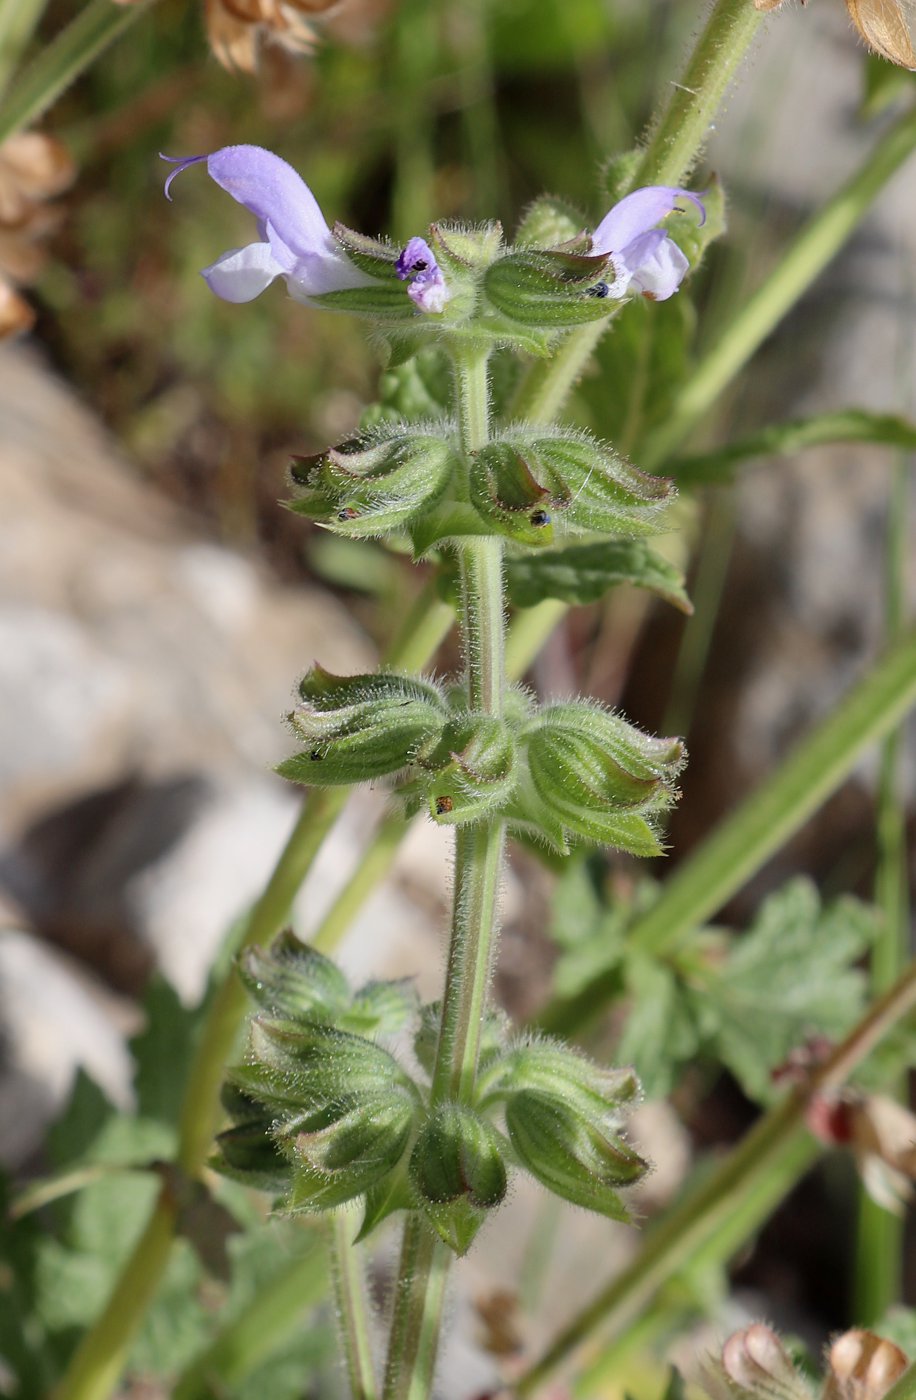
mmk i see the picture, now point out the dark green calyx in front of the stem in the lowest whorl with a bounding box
[409,1103,506,1254]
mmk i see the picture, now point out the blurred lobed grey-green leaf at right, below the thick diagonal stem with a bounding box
[692,879,877,1102]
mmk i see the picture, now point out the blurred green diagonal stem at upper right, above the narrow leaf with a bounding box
[640,108,916,470]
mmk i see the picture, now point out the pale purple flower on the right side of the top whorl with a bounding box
[591,185,706,301]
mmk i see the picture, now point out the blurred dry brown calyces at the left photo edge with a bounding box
[0,132,74,339]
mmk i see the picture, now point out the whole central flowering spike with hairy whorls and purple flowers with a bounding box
[167,146,706,1396]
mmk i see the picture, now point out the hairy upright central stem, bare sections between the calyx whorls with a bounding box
[384,346,506,1400]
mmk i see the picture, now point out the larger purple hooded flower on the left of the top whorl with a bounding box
[162,146,373,301]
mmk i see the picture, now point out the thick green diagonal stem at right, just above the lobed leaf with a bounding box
[541,633,916,1035]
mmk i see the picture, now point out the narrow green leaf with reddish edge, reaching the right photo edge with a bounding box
[669,409,916,486]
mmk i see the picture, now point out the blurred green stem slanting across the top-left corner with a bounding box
[0,0,155,141]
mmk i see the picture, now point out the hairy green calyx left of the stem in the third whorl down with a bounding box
[277,666,448,787]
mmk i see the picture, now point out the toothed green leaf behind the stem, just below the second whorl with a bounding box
[506,539,693,615]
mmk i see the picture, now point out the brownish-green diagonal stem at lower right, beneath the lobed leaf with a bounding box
[515,963,916,1400]
